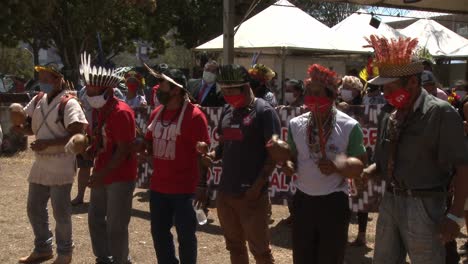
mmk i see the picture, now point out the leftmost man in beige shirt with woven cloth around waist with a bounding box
[14,65,88,264]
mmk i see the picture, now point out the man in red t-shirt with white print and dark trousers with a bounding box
[146,69,209,264]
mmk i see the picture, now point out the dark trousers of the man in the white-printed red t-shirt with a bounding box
[150,191,197,264]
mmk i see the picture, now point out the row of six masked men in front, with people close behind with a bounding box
[11,36,468,264]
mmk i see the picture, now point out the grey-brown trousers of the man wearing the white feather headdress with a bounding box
[88,182,135,264]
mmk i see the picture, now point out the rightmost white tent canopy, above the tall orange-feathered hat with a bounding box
[400,19,468,57]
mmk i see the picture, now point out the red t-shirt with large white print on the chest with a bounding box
[145,103,210,194]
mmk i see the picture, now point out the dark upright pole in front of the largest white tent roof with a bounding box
[223,0,234,64]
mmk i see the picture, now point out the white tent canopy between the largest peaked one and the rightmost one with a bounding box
[331,11,402,52]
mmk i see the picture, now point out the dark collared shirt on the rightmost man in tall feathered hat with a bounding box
[375,89,468,189]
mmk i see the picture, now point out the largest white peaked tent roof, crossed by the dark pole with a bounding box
[195,0,334,51]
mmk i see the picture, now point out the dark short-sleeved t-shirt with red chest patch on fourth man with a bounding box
[218,98,281,195]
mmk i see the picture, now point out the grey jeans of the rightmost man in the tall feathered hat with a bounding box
[373,192,446,264]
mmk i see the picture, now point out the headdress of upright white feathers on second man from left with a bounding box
[80,52,122,88]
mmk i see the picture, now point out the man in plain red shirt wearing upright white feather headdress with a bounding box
[80,52,137,264]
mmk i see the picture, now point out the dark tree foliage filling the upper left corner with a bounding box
[0,0,171,80]
